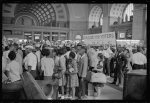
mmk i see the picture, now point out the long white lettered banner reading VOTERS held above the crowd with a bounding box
[83,32,116,46]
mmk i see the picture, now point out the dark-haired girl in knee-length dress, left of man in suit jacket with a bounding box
[67,52,79,99]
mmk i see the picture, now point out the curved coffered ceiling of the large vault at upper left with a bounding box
[14,3,56,25]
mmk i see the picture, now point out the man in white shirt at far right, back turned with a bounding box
[131,47,147,70]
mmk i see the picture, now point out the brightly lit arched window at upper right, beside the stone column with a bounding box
[123,4,133,22]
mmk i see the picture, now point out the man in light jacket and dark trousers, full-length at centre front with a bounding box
[78,47,88,99]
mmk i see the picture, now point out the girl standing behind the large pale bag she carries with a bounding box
[92,53,104,97]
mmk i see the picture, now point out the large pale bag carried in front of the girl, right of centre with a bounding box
[91,72,107,83]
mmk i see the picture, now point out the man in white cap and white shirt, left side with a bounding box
[24,45,37,78]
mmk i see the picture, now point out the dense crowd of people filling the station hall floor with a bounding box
[2,38,147,99]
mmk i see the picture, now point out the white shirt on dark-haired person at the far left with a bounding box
[6,61,21,82]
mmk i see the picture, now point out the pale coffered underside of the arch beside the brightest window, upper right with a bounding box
[110,4,128,18]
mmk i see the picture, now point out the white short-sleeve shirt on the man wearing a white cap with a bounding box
[24,52,37,70]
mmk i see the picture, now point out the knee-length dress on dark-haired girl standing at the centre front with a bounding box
[67,59,79,87]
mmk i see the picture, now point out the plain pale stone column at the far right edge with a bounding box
[132,4,146,41]
